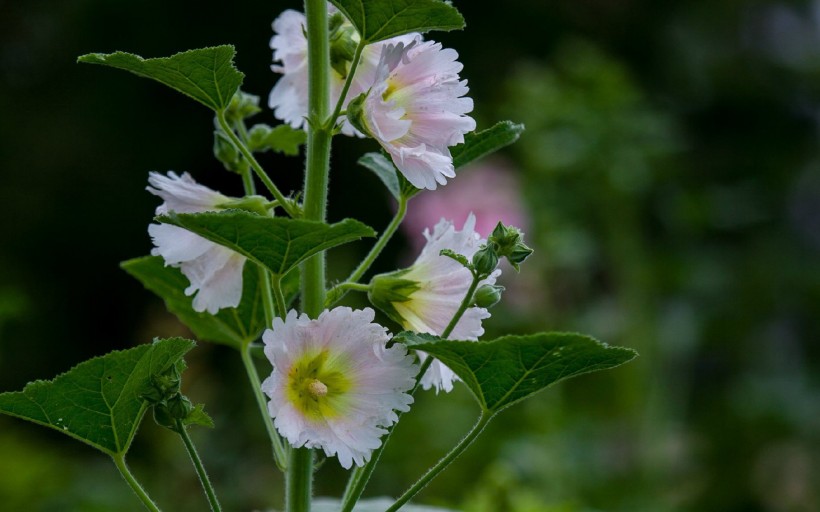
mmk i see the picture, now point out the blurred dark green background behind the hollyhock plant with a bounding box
[0,0,820,512]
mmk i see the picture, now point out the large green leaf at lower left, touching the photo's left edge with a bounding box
[0,338,194,457]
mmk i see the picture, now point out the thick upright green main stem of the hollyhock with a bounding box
[292,0,331,512]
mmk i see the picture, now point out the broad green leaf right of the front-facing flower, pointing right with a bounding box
[400,332,637,413]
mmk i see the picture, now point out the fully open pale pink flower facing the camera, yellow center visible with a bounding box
[262,307,418,469]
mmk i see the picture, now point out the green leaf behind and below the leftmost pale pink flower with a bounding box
[120,256,299,348]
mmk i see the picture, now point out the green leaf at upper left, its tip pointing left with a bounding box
[77,45,245,111]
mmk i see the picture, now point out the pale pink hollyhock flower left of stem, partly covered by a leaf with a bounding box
[146,172,246,315]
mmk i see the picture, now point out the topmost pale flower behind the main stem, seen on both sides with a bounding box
[268,4,414,137]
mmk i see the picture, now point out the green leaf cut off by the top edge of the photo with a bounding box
[330,0,464,43]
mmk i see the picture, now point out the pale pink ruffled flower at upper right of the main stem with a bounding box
[361,36,475,190]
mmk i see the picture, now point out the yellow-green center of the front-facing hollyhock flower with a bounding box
[287,351,352,421]
